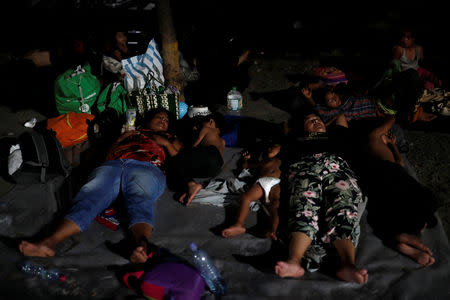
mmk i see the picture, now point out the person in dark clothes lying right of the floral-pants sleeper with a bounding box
[358,117,438,267]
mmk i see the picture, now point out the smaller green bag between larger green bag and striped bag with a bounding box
[96,82,128,116]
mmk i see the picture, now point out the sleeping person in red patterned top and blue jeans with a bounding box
[19,109,181,263]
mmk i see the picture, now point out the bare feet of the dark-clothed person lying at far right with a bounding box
[395,233,435,267]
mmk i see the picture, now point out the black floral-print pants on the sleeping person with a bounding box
[288,152,365,271]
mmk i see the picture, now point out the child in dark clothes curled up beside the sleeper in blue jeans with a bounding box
[167,113,225,205]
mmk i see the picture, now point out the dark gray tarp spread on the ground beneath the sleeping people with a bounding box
[0,106,450,300]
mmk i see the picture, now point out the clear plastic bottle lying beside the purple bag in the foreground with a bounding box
[190,243,227,296]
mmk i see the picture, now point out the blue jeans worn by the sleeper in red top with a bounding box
[66,159,166,231]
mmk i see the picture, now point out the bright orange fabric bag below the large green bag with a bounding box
[47,112,95,148]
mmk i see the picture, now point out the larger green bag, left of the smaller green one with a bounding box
[55,63,100,114]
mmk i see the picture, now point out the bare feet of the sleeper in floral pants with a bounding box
[275,260,369,284]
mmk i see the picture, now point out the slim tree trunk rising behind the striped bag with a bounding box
[156,0,185,102]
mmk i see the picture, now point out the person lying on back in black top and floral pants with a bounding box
[275,110,369,284]
